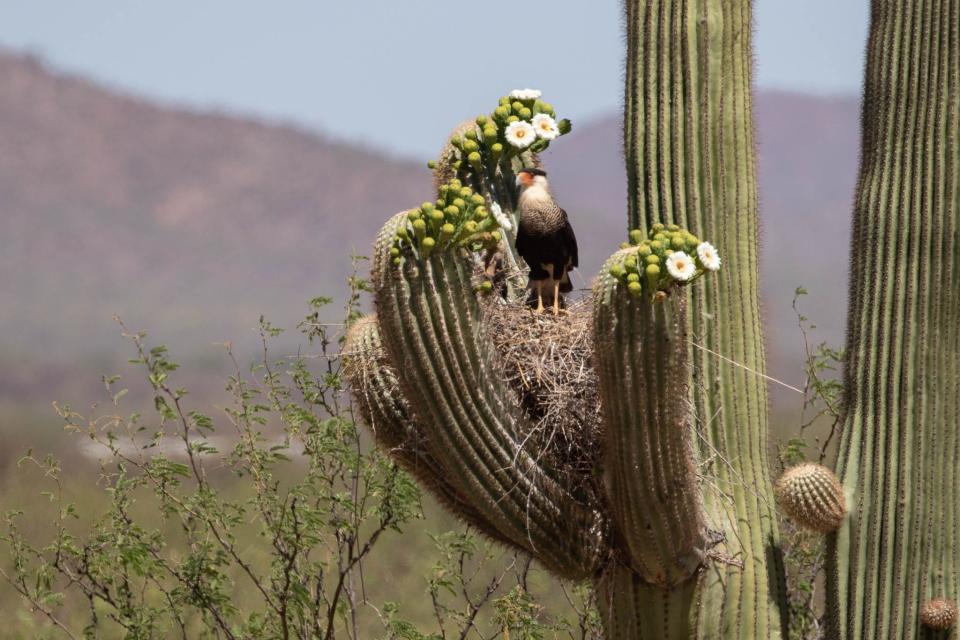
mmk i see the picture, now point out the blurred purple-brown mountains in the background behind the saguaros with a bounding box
[0,54,858,410]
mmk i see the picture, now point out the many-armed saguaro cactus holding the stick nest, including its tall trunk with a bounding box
[346,0,783,640]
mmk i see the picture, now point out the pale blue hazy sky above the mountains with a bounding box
[0,0,868,157]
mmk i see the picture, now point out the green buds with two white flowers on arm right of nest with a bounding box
[608,222,720,300]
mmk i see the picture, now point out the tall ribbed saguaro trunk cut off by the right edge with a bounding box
[828,0,960,638]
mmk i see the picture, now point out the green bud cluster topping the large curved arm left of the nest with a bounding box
[390,178,502,265]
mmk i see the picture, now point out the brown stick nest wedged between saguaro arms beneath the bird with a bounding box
[483,296,602,488]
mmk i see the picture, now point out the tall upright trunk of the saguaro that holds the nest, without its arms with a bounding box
[611,0,785,638]
